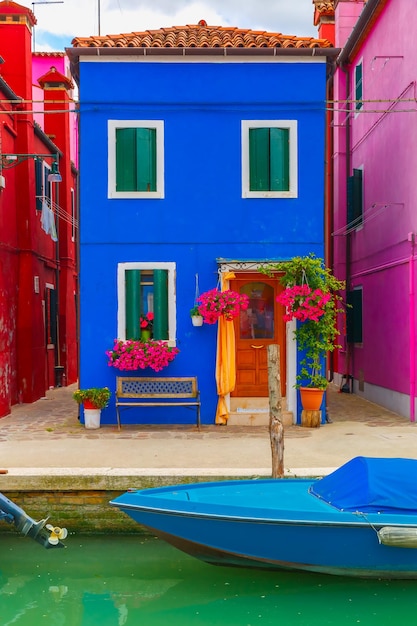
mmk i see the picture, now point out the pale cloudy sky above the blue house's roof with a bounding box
[15,0,317,52]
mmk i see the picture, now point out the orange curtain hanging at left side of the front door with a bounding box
[216,272,236,424]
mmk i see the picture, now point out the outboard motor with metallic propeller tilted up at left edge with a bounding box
[0,493,68,548]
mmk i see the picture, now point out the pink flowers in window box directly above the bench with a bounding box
[106,339,179,372]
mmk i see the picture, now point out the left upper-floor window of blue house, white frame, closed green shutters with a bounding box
[108,120,164,199]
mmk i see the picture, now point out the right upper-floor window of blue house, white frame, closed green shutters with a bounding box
[242,120,298,198]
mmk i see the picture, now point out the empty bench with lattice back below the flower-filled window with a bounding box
[116,376,201,430]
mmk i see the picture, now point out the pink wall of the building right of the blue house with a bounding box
[334,0,417,417]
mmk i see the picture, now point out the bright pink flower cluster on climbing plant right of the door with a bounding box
[277,285,331,322]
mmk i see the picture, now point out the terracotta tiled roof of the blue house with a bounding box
[72,22,332,48]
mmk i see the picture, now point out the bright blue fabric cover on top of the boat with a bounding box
[310,456,417,514]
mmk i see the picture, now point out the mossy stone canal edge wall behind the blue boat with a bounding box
[0,468,326,534]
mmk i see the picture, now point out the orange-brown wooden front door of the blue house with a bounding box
[230,273,286,398]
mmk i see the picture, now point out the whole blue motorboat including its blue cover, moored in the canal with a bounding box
[110,457,417,579]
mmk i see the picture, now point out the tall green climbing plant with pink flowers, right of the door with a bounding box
[263,254,345,389]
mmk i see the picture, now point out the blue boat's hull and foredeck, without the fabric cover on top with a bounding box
[111,479,417,579]
